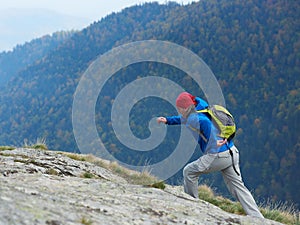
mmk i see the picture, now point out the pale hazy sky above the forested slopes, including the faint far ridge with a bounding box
[0,0,192,52]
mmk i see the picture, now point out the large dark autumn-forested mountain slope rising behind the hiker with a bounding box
[0,0,300,207]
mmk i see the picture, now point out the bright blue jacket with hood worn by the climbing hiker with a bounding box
[166,97,233,153]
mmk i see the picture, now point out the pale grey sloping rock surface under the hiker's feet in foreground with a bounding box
[0,148,280,225]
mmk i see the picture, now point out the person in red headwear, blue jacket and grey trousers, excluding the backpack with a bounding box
[157,92,263,218]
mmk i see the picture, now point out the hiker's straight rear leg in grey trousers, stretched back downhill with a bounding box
[222,147,263,218]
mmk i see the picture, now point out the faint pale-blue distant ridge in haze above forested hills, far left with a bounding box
[0,8,92,52]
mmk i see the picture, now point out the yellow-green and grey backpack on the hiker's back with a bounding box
[197,105,236,141]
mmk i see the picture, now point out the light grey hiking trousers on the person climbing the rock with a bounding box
[183,146,263,218]
